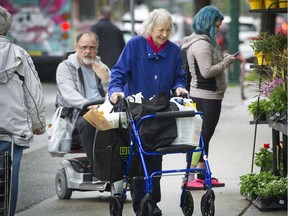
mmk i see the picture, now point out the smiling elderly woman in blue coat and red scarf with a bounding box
[108,9,187,215]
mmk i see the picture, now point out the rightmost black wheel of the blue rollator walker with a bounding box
[201,189,215,216]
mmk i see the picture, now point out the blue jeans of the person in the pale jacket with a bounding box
[0,141,23,216]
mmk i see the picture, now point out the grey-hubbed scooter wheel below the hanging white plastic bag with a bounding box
[55,168,72,199]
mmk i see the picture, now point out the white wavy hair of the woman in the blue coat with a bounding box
[138,8,173,37]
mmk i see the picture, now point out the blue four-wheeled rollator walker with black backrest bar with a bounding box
[110,99,215,216]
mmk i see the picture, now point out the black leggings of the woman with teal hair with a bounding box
[192,97,222,162]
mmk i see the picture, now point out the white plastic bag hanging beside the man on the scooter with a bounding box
[47,107,68,156]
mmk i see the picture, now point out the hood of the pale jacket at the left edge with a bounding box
[0,36,21,84]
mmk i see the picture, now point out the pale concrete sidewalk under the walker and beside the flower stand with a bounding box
[16,87,287,216]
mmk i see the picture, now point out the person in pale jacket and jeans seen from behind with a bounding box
[0,6,46,216]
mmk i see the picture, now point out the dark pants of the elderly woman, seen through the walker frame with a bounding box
[132,155,162,213]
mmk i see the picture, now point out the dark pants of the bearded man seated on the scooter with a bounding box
[75,116,96,164]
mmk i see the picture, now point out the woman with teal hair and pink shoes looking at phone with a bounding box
[182,6,237,190]
